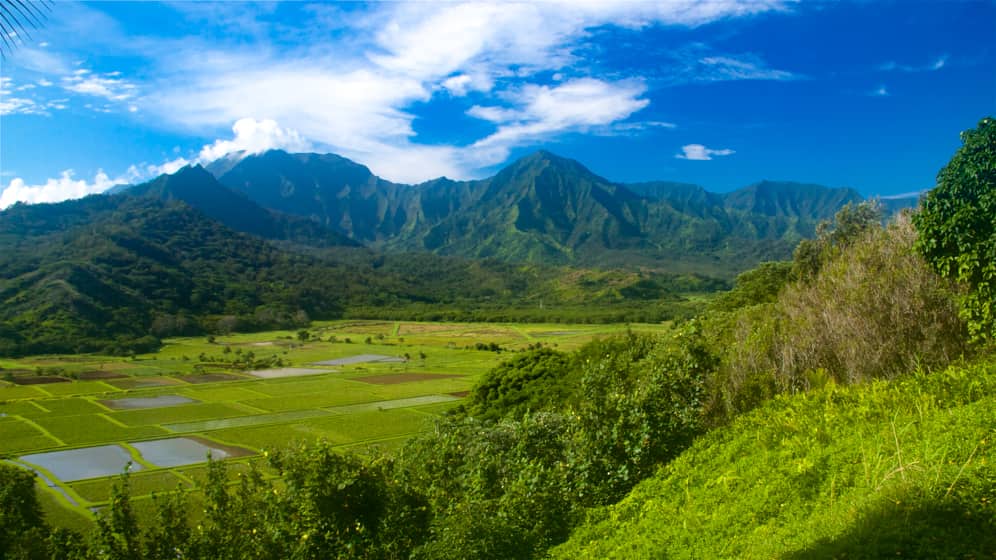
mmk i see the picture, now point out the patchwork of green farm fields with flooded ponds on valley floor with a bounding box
[0,321,662,526]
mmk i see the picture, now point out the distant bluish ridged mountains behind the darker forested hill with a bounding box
[208,151,904,274]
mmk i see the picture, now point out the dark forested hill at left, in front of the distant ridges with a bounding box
[0,175,726,355]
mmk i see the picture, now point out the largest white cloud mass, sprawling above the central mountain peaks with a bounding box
[141,0,794,181]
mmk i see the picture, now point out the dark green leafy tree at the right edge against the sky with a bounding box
[913,117,996,341]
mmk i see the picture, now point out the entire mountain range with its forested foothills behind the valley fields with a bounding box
[0,151,920,355]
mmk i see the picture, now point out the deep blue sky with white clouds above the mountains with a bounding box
[0,0,996,208]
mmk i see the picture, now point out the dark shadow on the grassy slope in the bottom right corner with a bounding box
[782,502,996,560]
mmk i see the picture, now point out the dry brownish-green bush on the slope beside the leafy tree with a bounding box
[725,216,966,402]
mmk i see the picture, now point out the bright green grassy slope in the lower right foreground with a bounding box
[553,361,996,559]
